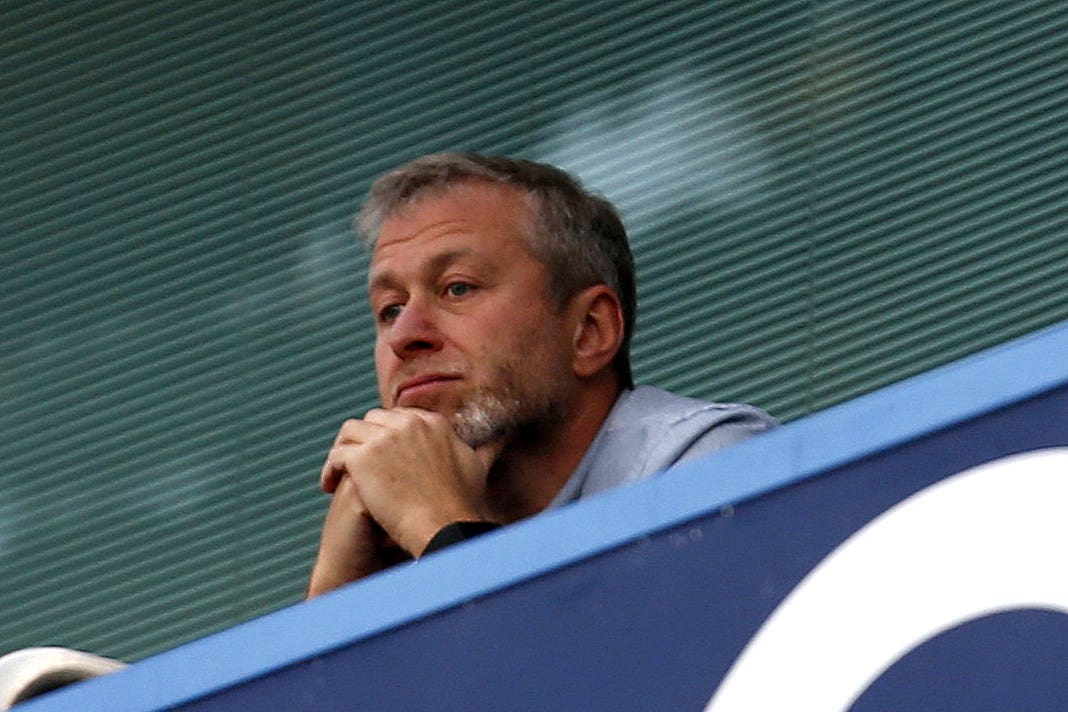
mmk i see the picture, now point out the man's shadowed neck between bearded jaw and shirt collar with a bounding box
[486,377,621,524]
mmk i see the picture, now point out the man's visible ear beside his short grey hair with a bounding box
[570,284,624,378]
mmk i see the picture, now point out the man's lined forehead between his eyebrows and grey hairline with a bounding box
[371,181,533,279]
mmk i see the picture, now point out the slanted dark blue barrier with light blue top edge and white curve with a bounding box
[19,323,1068,712]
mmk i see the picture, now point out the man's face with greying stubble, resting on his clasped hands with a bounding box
[368,183,575,446]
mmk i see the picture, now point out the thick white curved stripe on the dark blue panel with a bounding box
[706,448,1068,712]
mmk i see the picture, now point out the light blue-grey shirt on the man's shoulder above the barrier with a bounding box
[549,385,776,508]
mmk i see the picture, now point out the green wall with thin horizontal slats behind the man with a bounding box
[0,0,1068,660]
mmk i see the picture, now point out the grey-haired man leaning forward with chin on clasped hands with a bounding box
[309,154,773,596]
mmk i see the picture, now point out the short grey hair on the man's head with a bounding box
[357,154,638,387]
